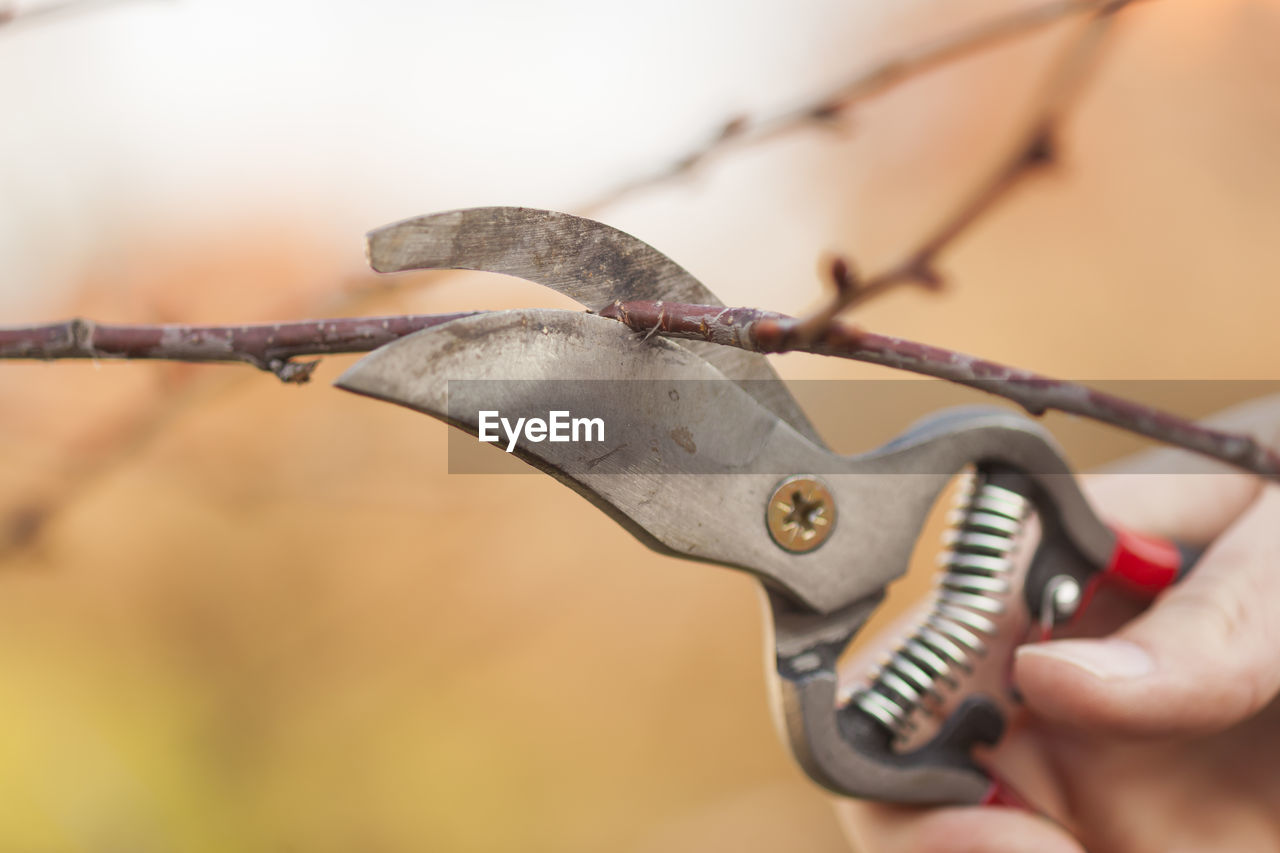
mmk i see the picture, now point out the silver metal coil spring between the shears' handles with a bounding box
[852,476,1029,738]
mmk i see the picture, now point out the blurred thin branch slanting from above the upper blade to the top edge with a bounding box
[580,0,1133,215]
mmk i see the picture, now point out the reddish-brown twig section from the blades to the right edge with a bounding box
[602,302,1280,482]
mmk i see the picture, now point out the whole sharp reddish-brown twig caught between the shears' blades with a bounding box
[0,302,1280,480]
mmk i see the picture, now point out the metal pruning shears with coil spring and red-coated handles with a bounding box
[337,207,1196,804]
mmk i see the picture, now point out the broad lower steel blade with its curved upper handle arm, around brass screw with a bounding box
[337,309,1090,613]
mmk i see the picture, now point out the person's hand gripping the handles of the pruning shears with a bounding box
[838,400,1280,853]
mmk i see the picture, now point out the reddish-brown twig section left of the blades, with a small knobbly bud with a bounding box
[0,311,471,384]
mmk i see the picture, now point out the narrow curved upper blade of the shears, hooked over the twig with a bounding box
[369,207,822,446]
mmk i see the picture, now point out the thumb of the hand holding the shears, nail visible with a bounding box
[1015,485,1280,734]
